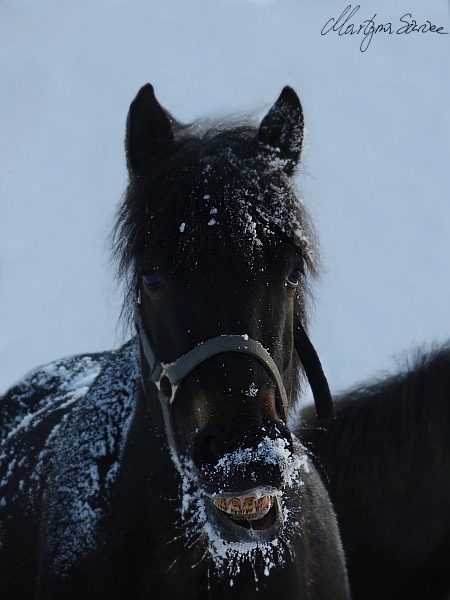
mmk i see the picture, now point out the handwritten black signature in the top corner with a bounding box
[320,4,448,52]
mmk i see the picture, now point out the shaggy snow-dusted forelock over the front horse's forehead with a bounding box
[110,119,320,336]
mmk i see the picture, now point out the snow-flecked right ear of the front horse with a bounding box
[257,86,304,174]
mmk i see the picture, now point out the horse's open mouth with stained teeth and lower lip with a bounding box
[205,493,283,544]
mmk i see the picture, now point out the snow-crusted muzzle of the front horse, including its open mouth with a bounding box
[194,422,293,543]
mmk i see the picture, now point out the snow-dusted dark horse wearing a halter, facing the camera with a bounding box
[0,85,349,600]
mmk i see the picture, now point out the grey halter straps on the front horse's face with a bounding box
[134,303,335,454]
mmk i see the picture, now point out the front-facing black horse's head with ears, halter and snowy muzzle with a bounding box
[112,84,330,556]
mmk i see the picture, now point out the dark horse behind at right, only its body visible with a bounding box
[299,346,450,600]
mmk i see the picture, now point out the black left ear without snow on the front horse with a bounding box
[125,83,174,174]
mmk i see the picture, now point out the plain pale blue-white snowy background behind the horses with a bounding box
[0,0,450,400]
